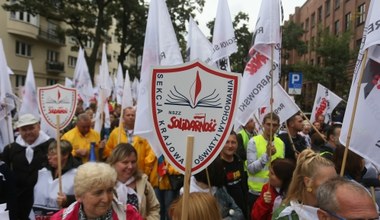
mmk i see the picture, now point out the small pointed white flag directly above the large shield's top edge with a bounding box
[186,16,214,65]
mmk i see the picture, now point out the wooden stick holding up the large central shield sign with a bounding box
[181,135,194,220]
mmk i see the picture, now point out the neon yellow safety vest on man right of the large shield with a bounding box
[248,135,285,193]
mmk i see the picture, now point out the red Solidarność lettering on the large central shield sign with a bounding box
[168,115,216,132]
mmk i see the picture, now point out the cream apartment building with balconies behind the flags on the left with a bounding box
[0,0,131,93]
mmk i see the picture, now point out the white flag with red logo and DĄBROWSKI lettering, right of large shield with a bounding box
[236,0,281,125]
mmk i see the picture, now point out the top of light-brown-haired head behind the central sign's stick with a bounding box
[169,192,222,220]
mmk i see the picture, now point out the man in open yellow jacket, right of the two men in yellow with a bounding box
[103,107,152,174]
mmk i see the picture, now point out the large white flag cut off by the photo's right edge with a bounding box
[339,1,380,166]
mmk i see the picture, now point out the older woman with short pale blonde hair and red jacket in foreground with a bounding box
[50,162,142,220]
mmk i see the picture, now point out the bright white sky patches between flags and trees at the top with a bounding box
[195,0,306,36]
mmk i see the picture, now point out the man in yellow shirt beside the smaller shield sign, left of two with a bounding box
[62,113,100,163]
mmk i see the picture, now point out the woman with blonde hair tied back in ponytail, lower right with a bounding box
[272,149,337,220]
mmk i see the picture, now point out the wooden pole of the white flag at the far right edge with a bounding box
[340,49,368,176]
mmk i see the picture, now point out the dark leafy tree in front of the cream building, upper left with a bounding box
[3,0,113,81]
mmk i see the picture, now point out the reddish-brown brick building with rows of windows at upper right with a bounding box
[287,0,370,109]
